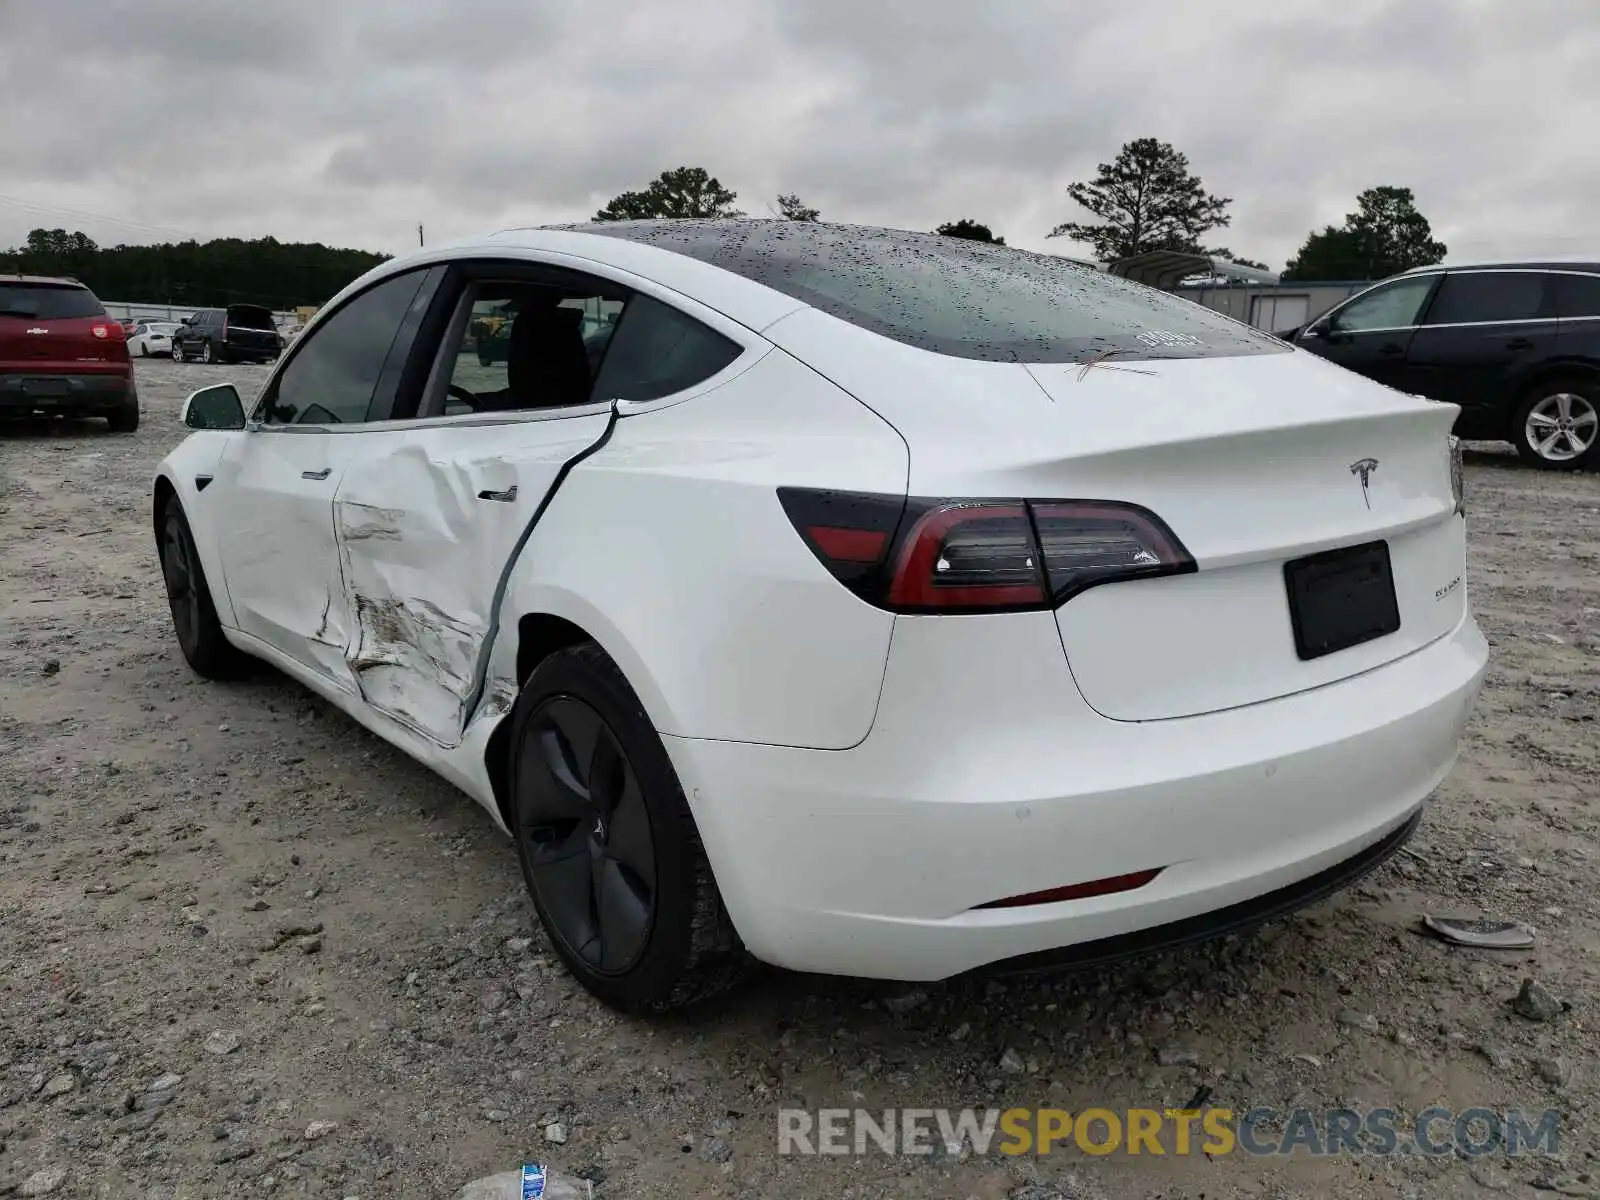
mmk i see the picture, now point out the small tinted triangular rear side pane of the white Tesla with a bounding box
[594,296,742,400]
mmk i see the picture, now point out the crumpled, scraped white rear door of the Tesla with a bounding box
[333,405,610,746]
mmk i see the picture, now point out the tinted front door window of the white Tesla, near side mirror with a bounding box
[261,270,427,426]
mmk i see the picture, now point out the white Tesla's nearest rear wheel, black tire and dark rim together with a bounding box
[507,643,752,1013]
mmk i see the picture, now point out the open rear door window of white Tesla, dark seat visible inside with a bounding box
[435,280,632,416]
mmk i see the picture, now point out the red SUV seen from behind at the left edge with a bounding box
[0,275,139,434]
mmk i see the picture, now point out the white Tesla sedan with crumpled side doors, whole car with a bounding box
[154,221,1486,1010]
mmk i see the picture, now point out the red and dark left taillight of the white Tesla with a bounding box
[778,488,1195,613]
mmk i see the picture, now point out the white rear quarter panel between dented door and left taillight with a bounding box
[490,342,909,749]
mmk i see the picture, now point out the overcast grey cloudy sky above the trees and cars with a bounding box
[0,0,1600,269]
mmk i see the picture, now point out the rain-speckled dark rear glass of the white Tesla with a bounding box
[578,221,1290,363]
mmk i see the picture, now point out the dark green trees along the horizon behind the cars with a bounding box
[0,138,1446,309]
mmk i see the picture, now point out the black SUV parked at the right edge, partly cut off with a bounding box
[1282,262,1600,469]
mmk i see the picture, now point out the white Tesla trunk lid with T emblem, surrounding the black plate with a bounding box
[765,310,1466,720]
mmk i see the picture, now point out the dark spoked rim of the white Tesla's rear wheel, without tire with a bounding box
[517,696,656,971]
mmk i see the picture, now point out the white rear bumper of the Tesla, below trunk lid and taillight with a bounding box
[666,614,1488,979]
